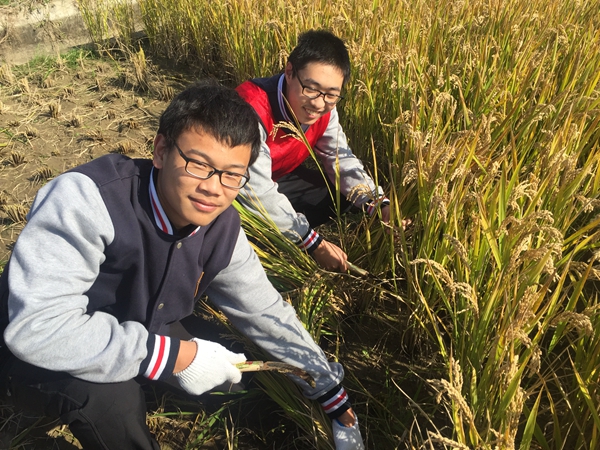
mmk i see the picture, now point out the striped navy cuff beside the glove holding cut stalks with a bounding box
[140,334,180,380]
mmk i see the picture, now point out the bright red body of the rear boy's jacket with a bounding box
[236,79,330,181]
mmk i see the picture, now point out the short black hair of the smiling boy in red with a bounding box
[288,30,350,84]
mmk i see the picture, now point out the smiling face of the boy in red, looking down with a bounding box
[285,62,344,125]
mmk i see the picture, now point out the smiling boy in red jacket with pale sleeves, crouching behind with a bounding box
[237,30,390,272]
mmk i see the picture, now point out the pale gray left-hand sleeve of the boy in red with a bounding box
[238,126,320,250]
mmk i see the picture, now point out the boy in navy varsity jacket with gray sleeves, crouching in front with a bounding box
[0,84,363,450]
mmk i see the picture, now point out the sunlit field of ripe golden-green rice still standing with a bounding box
[32,0,600,450]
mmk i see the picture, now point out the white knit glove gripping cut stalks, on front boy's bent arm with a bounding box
[173,338,246,395]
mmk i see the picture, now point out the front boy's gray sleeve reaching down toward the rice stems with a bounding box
[206,230,344,399]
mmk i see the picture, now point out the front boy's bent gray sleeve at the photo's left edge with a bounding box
[4,173,173,382]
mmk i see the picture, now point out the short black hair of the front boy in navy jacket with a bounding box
[157,80,261,165]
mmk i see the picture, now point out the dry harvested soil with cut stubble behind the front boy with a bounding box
[0,50,191,265]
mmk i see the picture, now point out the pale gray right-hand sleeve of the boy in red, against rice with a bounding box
[315,108,383,207]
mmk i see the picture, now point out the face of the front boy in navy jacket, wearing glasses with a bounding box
[153,129,251,229]
